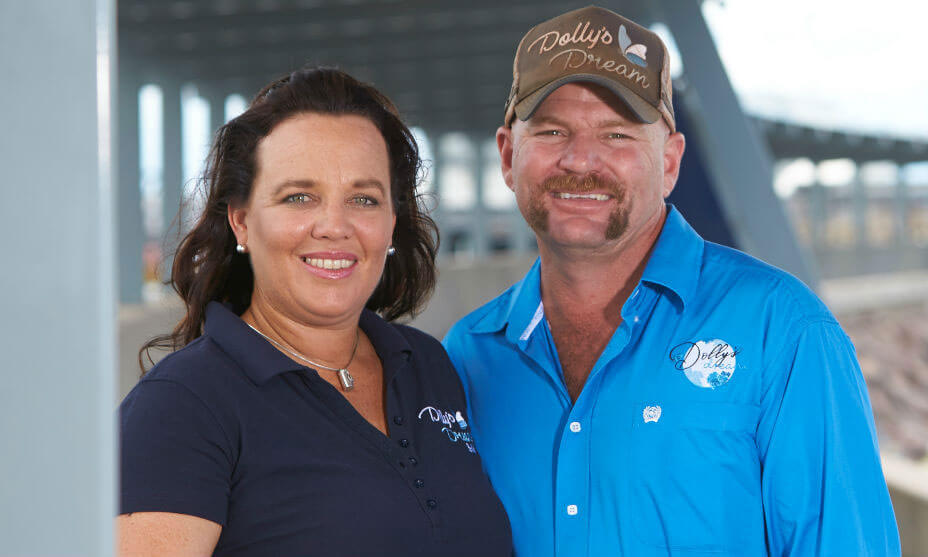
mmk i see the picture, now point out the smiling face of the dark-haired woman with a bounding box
[229,114,396,325]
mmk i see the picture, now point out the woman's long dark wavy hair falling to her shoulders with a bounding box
[139,68,438,371]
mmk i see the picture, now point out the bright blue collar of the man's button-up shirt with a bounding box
[471,203,705,334]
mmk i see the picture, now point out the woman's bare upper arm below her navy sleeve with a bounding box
[116,512,222,557]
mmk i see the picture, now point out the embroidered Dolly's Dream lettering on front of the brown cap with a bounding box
[525,17,651,89]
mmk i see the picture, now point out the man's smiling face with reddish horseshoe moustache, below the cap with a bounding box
[497,83,684,250]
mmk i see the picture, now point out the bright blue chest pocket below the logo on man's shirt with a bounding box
[629,401,764,555]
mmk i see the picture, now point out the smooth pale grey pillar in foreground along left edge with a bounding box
[0,0,117,557]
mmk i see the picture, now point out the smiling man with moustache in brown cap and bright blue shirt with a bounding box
[445,7,900,557]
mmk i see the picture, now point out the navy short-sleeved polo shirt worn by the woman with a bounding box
[120,302,511,557]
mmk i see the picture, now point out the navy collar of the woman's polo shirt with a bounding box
[204,302,412,385]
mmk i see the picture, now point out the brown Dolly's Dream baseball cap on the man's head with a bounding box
[505,6,676,131]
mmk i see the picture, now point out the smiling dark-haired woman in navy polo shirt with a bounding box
[117,69,511,557]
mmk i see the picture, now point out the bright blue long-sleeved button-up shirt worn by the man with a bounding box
[445,207,900,557]
